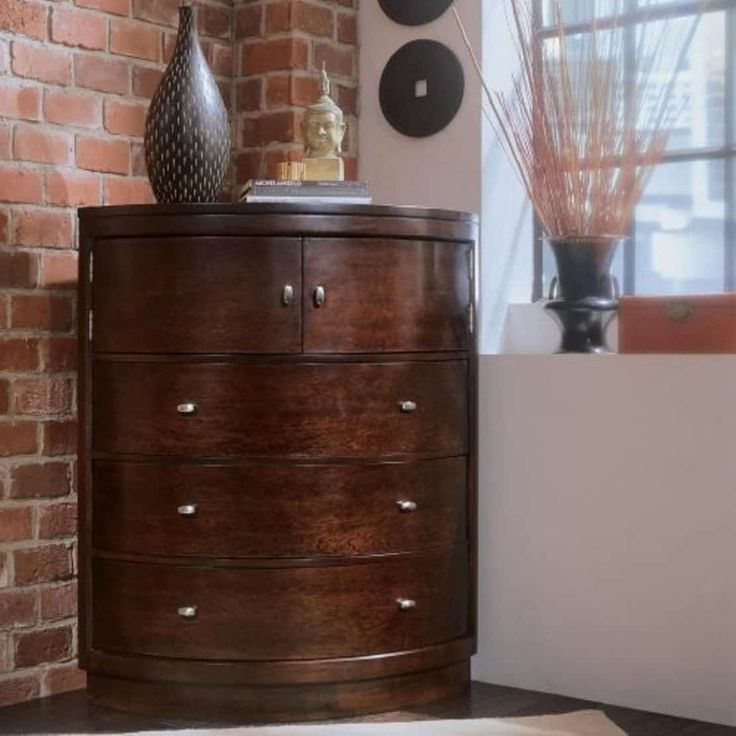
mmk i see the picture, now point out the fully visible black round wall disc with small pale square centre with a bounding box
[379,39,465,138]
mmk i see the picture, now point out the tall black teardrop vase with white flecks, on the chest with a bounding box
[145,6,230,203]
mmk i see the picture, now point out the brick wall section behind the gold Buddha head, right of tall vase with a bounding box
[233,0,358,186]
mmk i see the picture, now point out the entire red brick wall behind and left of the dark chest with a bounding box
[0,0,358,706]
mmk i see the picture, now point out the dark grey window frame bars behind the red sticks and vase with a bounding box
[532,0,736,301]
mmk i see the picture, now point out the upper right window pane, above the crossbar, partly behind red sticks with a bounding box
[637,13,726,150]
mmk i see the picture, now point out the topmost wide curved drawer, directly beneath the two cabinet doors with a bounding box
[93,361,468,458]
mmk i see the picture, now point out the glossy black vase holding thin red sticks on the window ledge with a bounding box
[546,237,625,353]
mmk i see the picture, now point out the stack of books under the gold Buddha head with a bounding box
[240,179,373,204]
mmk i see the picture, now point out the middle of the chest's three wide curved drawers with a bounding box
[93,457,467,557]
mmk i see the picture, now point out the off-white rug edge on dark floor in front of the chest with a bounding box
[85,710,626,736]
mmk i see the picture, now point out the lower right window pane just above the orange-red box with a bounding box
[636,161,725,294]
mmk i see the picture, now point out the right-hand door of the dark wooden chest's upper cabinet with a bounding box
[304,238,471,353]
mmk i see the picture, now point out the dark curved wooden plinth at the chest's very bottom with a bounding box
[87,661,470,723]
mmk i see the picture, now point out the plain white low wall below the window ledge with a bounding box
[474,355,736,725]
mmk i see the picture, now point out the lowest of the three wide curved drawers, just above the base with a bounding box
[93,550,468,660]
